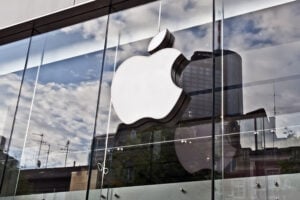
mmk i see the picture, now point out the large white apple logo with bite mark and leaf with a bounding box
[111,30,190,126]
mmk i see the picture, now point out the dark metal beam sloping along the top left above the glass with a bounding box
[0,0,157,45]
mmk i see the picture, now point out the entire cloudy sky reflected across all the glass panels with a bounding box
[0,1,300,167]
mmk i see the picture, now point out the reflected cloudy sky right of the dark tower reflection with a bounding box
[224,2,300,148]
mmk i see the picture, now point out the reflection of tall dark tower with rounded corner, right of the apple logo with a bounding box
[181,50,243,119]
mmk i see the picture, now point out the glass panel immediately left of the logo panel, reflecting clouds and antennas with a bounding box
[0,14,107,199]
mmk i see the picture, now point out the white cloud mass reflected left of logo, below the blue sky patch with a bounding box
[6,73,119,168]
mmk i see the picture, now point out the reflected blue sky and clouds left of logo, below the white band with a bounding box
[0,52,101,168]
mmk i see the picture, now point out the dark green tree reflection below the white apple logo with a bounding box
[104,126,211,187]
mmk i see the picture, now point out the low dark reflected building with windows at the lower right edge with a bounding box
[224,144,300,178]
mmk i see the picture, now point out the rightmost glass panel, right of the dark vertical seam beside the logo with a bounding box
[216,0,300,199]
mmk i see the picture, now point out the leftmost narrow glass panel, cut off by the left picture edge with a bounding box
[0,39,30,196]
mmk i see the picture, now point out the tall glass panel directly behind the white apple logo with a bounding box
[93,0,213,199]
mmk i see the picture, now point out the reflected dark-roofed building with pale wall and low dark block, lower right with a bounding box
[218,109,300,178]
